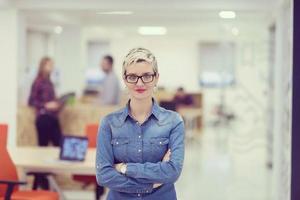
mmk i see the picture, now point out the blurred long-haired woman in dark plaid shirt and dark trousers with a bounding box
[28,57,62,189]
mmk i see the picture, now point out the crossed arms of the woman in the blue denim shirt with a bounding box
[96,118,184,193]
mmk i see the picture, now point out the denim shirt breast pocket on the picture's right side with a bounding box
[150,137,169,162]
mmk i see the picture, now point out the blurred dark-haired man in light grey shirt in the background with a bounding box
[99,55,120,105]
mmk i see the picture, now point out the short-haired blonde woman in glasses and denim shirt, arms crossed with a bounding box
[96,48,184,200]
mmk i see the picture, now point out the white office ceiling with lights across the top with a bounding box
[0,0,281,35]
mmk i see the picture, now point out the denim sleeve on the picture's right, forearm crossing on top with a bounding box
[126,117,184,183]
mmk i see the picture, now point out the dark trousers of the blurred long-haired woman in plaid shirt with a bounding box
[32,114,62,190]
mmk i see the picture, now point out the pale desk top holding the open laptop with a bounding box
[8,147,96,175]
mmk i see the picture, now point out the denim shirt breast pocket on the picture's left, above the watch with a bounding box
[111,138,129,163]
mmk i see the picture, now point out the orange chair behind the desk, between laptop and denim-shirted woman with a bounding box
[73,124,104,199]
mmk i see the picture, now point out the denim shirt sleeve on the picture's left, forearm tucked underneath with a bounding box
[96,117,153,193]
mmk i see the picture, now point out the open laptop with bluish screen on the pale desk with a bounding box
[59,136,88,161]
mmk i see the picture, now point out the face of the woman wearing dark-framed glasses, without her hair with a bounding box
[123,62,159,100]
